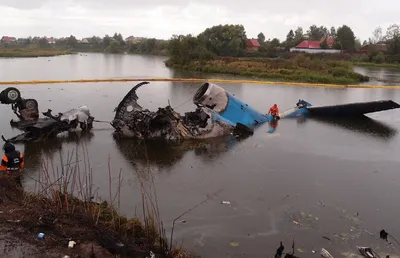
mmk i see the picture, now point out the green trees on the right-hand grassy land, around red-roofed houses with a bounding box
[167,24,400,65]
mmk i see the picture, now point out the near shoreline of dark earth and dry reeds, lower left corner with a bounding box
[0,149,197,258]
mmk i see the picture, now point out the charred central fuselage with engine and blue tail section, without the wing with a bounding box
[111,82,272,141]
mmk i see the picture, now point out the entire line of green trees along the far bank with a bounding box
[2,24,400,65]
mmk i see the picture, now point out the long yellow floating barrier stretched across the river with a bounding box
[0,78,400,89]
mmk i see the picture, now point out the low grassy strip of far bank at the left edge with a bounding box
[0,48,71,57]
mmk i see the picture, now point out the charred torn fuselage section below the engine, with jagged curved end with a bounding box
[111,82,260,141]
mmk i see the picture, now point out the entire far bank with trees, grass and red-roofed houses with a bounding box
[0,24,400,84]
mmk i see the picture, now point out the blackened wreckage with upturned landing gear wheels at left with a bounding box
[0,87,94,143]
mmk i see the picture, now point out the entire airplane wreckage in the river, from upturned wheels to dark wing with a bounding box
[0,82,400,142]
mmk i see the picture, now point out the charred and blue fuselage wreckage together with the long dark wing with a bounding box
[111,82,400,141]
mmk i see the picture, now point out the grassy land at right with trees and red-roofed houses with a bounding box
[166,25,400,84]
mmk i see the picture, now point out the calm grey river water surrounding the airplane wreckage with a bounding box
[0,54,400,257]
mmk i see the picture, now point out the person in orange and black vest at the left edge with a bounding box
[0,142,25,184]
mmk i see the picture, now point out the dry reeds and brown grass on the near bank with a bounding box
[0,143,195,258]
